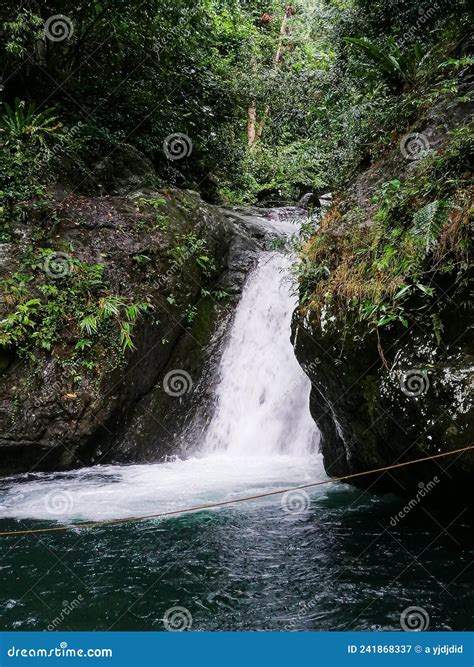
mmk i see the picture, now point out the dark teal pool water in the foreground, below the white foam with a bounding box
[0,472,474,631]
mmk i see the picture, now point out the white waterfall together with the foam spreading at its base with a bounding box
[0,221,324,522]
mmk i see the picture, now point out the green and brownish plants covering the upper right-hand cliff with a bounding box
[297,123,472,336]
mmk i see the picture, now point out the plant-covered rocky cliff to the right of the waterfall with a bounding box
[293,103,474,506]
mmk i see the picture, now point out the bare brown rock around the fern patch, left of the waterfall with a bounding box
[0,191,224,474]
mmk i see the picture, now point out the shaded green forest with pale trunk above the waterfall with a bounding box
[0,0,472,206]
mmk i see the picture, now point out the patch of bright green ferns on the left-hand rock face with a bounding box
[0,253,151,361]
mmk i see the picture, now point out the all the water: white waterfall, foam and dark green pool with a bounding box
[0,218,472,630]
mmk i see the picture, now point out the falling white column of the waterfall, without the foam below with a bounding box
[203,252,317,456]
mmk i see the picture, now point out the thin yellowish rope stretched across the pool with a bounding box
[0,445,474,537]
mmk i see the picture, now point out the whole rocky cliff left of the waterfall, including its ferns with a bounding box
[0,180,286,474]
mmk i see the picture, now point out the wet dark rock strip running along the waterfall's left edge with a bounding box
[98,208,292,462]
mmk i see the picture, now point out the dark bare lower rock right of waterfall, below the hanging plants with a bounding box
[293,311,474,507]
